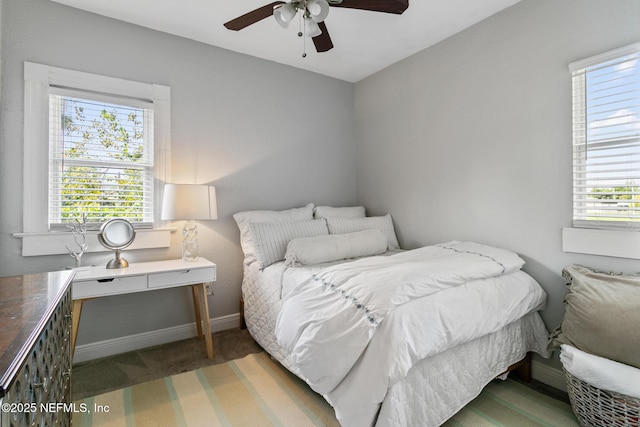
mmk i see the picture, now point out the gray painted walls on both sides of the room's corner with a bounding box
[0,0,640,372]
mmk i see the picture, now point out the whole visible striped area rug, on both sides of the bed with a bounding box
[73,353,578,427]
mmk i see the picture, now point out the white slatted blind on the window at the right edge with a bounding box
[570,43,640,229]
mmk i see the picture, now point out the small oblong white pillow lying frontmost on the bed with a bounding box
[284,230,387,267]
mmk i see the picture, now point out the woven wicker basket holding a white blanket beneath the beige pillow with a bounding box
[563,369,640,427]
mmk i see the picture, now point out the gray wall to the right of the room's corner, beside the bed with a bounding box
[355,0,640,368]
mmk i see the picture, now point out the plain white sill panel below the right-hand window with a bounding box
[562,228,640,259]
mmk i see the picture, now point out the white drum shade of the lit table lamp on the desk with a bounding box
[161,184,218,220]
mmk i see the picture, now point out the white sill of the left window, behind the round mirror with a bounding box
[14,228,175,256]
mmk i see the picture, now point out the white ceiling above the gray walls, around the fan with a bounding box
[52,0,520,82]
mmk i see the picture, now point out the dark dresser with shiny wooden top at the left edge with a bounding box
[0,271,74,427]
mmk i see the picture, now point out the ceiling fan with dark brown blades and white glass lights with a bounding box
[224,0,409,57]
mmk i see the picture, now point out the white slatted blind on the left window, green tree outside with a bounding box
[48,87,154,229]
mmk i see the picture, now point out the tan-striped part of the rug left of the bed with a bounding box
[73,352,339,427]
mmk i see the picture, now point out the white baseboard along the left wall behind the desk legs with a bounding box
[73,313,240,363]
